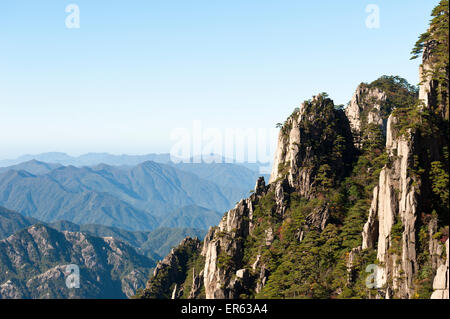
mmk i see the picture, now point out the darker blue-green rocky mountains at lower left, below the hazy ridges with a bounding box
[0,207,206,298]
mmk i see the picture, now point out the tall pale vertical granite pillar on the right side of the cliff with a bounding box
[362,115,418,298]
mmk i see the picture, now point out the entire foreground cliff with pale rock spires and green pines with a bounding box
[139,1,449,298]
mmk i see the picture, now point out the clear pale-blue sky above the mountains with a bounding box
[0,0,438,159]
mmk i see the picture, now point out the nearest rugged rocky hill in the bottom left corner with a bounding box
[0,225,154,299]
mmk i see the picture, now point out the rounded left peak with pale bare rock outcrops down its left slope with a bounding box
[202,95,354,298]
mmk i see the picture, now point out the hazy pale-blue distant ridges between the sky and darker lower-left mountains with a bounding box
[0,160,264,230]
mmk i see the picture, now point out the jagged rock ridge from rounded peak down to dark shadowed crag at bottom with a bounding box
[141,95,356,298]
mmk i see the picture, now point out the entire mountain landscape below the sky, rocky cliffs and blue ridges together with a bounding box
[0,0,450,299]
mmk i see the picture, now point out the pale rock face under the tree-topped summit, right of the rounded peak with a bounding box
[345,83,387,143]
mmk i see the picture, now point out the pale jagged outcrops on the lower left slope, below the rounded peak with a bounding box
[201,170,296,299]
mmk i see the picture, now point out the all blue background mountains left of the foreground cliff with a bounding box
[0,153,268,298]
